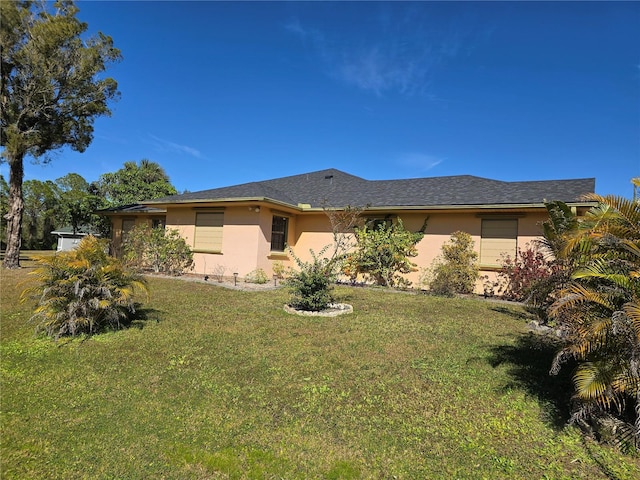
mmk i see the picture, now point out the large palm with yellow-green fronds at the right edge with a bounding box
[550,194,640,448]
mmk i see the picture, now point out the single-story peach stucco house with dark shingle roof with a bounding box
[103,169,595,290]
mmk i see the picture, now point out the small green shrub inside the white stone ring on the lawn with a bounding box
[286,245,335,312]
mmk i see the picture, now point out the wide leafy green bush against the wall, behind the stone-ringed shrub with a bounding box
[343,218,424,287]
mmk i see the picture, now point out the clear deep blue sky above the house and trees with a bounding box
[6,1,640,196]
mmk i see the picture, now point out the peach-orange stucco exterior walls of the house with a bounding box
[112,205,546,292]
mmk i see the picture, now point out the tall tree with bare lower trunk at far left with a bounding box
[0,0,120,268]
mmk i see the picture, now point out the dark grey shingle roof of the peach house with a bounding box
[145,169,595,207]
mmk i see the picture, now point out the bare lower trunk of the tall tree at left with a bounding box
[2,155,24,268]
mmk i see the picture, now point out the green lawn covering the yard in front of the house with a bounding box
[0,262,640,479]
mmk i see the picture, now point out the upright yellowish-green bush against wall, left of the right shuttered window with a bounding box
[429,231,478,296]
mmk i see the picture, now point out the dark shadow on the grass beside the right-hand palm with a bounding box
[490,333,574,430]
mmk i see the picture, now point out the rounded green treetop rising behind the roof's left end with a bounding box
[97,159,178,207]
